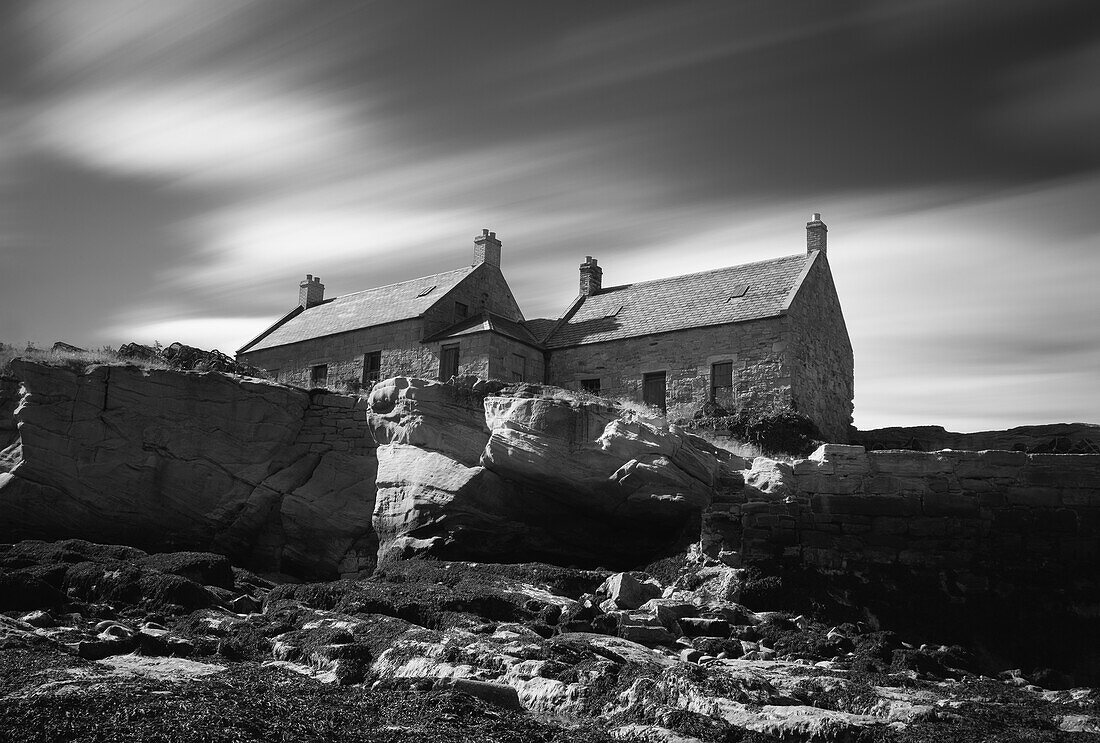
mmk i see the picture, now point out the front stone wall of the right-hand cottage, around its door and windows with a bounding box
[548,317,791,418]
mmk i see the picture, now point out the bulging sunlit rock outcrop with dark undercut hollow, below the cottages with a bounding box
[371,379,721,567]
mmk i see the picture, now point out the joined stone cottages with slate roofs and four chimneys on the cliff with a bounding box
[238,214,854,441]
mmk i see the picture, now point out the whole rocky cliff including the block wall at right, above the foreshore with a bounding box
[0,363,1100,676]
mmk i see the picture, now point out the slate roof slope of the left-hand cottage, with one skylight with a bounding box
[238,265,479,353]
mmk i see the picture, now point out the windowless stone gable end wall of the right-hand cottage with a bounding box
[788,253,855,444]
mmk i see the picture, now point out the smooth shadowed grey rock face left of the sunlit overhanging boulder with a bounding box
[0,361,376,577]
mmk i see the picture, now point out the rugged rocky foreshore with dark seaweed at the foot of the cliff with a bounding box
[0,540,1100,743]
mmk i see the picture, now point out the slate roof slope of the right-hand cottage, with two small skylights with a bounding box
[543,253,816,348]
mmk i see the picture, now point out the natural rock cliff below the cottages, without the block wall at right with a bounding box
[0,361,744,578]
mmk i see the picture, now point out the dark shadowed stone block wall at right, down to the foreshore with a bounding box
[704,445,1100,675]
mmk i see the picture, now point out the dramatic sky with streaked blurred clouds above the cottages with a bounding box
[0,0,1100,430]
